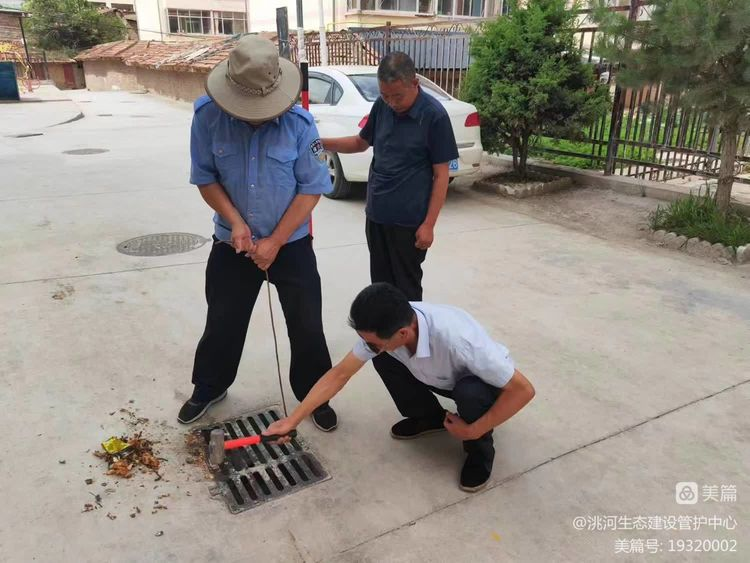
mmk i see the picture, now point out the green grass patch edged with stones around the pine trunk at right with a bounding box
[649,189,750,249]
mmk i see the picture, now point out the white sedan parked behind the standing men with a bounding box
[309,66,482,199]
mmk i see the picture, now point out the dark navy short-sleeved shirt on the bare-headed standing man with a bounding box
[359,88,458,228]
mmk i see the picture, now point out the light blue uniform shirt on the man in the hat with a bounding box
[190,96,333,242]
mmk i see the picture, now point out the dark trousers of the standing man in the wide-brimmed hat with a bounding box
[192,236,331,402]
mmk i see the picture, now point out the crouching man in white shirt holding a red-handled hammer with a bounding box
[264,283,534,492]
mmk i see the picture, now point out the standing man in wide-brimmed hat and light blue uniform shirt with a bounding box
[177,36,337,431]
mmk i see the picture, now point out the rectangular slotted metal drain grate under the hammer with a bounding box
[196,408,330,514]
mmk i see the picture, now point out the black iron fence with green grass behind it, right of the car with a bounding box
[534,0,750,183]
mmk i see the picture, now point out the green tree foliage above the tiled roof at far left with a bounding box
[24,0,127,53]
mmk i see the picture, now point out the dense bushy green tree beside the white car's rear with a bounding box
[462,0,609,177]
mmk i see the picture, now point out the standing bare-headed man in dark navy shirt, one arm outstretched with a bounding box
[321,52,458,301]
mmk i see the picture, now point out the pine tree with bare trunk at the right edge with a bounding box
[594,0,750,213]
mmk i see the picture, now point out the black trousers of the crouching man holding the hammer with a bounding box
[376,353,502,471]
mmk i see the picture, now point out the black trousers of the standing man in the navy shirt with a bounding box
[365,219,427,301]
